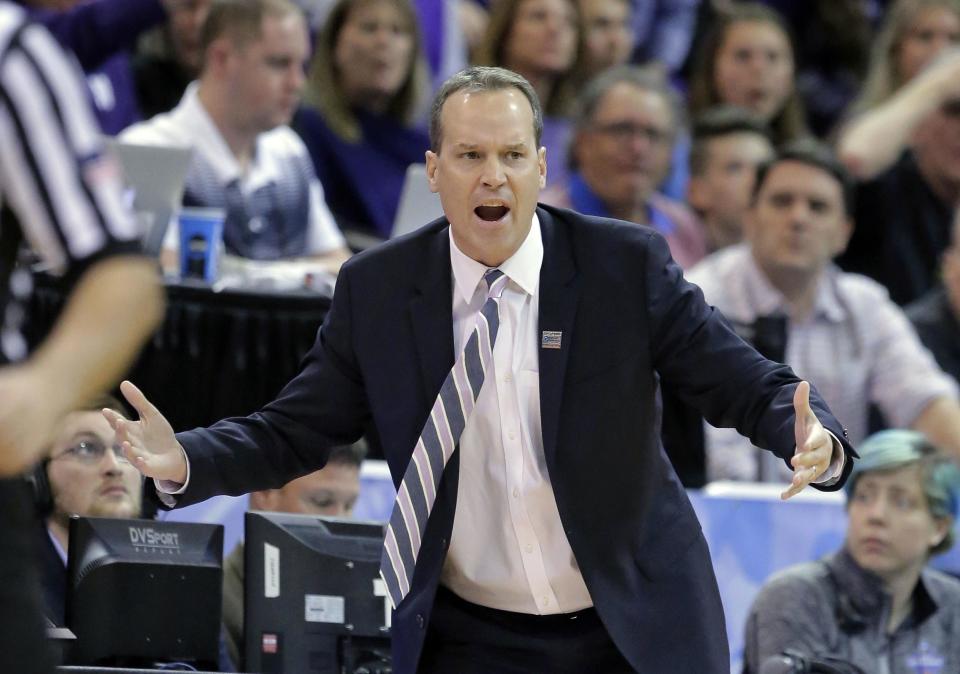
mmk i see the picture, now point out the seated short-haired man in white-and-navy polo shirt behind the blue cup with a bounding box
[122,0,349,272]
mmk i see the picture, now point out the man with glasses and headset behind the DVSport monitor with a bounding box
[33,396,143,625]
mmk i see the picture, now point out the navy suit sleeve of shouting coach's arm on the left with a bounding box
[177,267,370,507]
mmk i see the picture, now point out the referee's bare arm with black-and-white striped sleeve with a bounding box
[0,15,163,475]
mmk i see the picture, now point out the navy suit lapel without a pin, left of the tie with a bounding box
[409,220,454,410]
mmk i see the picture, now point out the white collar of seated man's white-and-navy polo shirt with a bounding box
[177,82,280,190]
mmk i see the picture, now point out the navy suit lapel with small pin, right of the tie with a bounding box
[537,208,580,466]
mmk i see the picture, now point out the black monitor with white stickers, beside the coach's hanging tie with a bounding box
[243,512,390,674]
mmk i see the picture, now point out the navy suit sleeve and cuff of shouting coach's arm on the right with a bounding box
[646,234,855,484]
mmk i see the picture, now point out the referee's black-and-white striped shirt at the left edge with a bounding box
[0,0,139,362]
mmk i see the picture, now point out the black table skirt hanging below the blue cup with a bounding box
[26,274,330,431]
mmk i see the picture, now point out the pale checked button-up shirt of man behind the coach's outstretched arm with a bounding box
[687,244,957,482]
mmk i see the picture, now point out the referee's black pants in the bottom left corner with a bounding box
[0,478,53,674]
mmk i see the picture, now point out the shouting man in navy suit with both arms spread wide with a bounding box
[107,68,854,674]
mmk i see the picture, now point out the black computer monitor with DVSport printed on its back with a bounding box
[66,517,223,670]
